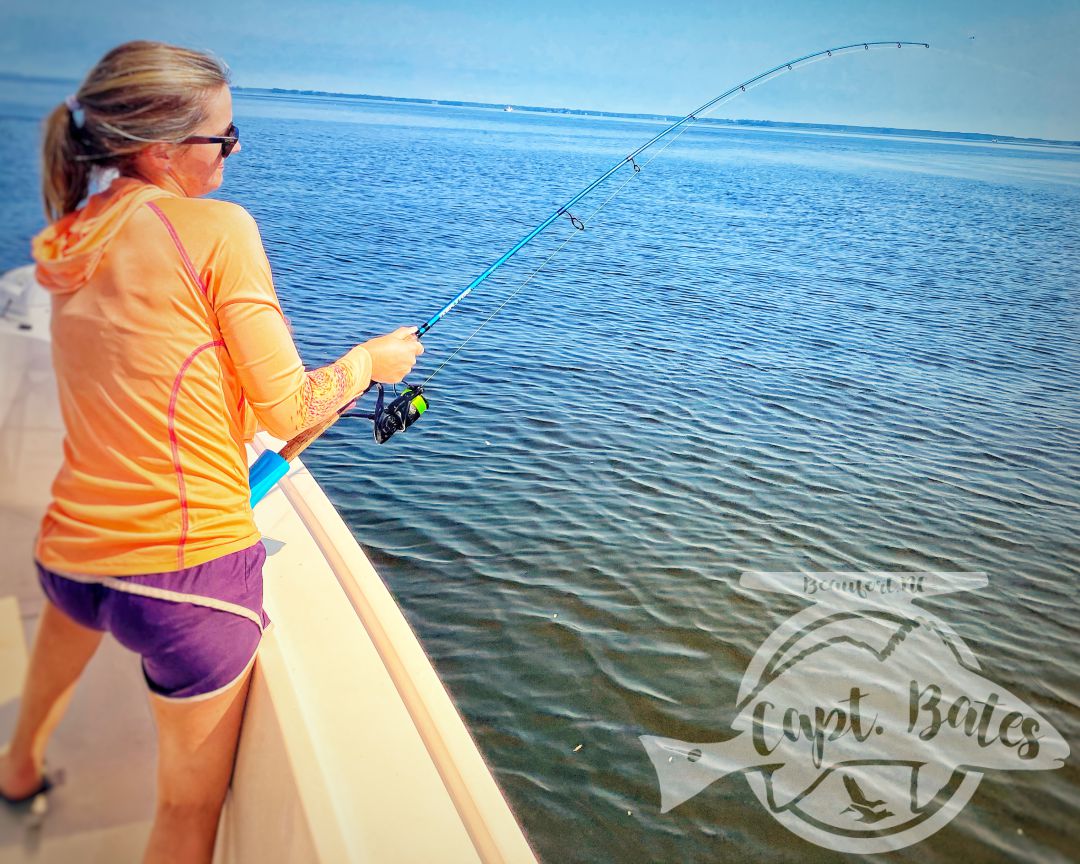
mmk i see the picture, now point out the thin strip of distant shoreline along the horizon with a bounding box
[0,71,1080,148]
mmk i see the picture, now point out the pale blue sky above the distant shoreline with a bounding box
[6,0,1080,139]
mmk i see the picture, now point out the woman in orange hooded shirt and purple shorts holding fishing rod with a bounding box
[0,42,423,862]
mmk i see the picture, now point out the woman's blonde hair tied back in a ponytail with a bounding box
[41,41,229,221]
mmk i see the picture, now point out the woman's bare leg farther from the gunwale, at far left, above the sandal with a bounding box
[0,598,105,797]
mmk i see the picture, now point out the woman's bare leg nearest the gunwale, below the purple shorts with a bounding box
[143,667,252,864]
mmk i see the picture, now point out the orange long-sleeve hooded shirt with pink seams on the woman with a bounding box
[33,178,372,577]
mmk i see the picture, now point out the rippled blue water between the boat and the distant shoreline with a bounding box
[0,77,1080,864]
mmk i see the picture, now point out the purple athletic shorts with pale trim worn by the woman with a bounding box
[38,542,270,699]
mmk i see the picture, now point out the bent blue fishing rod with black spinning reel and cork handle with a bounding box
[249,40,930,507]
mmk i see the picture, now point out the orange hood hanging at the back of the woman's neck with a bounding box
[32,177,172,294]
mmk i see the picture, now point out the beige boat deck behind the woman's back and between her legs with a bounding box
[0,270,156,864]
